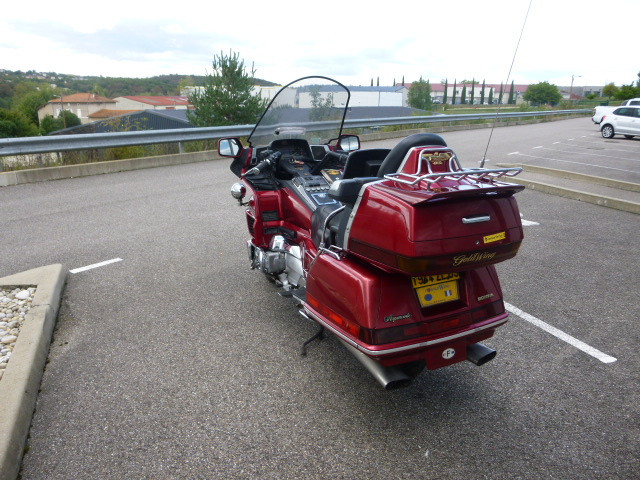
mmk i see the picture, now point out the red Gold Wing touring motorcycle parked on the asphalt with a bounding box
[218,77,524,389]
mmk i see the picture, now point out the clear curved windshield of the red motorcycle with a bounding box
[249,77,350,147]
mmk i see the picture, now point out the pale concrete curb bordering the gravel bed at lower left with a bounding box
[0,264,67,480]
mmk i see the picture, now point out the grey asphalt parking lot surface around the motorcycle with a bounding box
[0,118,640,479]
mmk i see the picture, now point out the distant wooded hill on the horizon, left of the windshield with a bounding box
[0,69,277,108]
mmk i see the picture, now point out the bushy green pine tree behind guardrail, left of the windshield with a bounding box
[187,52,267,127]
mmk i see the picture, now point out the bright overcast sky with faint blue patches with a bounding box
[0,0,640,86]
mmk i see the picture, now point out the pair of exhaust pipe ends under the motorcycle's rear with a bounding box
[339,339,496,390]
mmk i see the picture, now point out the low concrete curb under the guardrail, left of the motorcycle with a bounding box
[0,150,220,187]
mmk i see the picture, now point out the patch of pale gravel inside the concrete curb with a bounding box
[0,286,36,379]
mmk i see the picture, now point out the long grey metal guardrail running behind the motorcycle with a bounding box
[0,109,591,156]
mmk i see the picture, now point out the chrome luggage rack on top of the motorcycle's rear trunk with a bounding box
[384,147,522,190]
